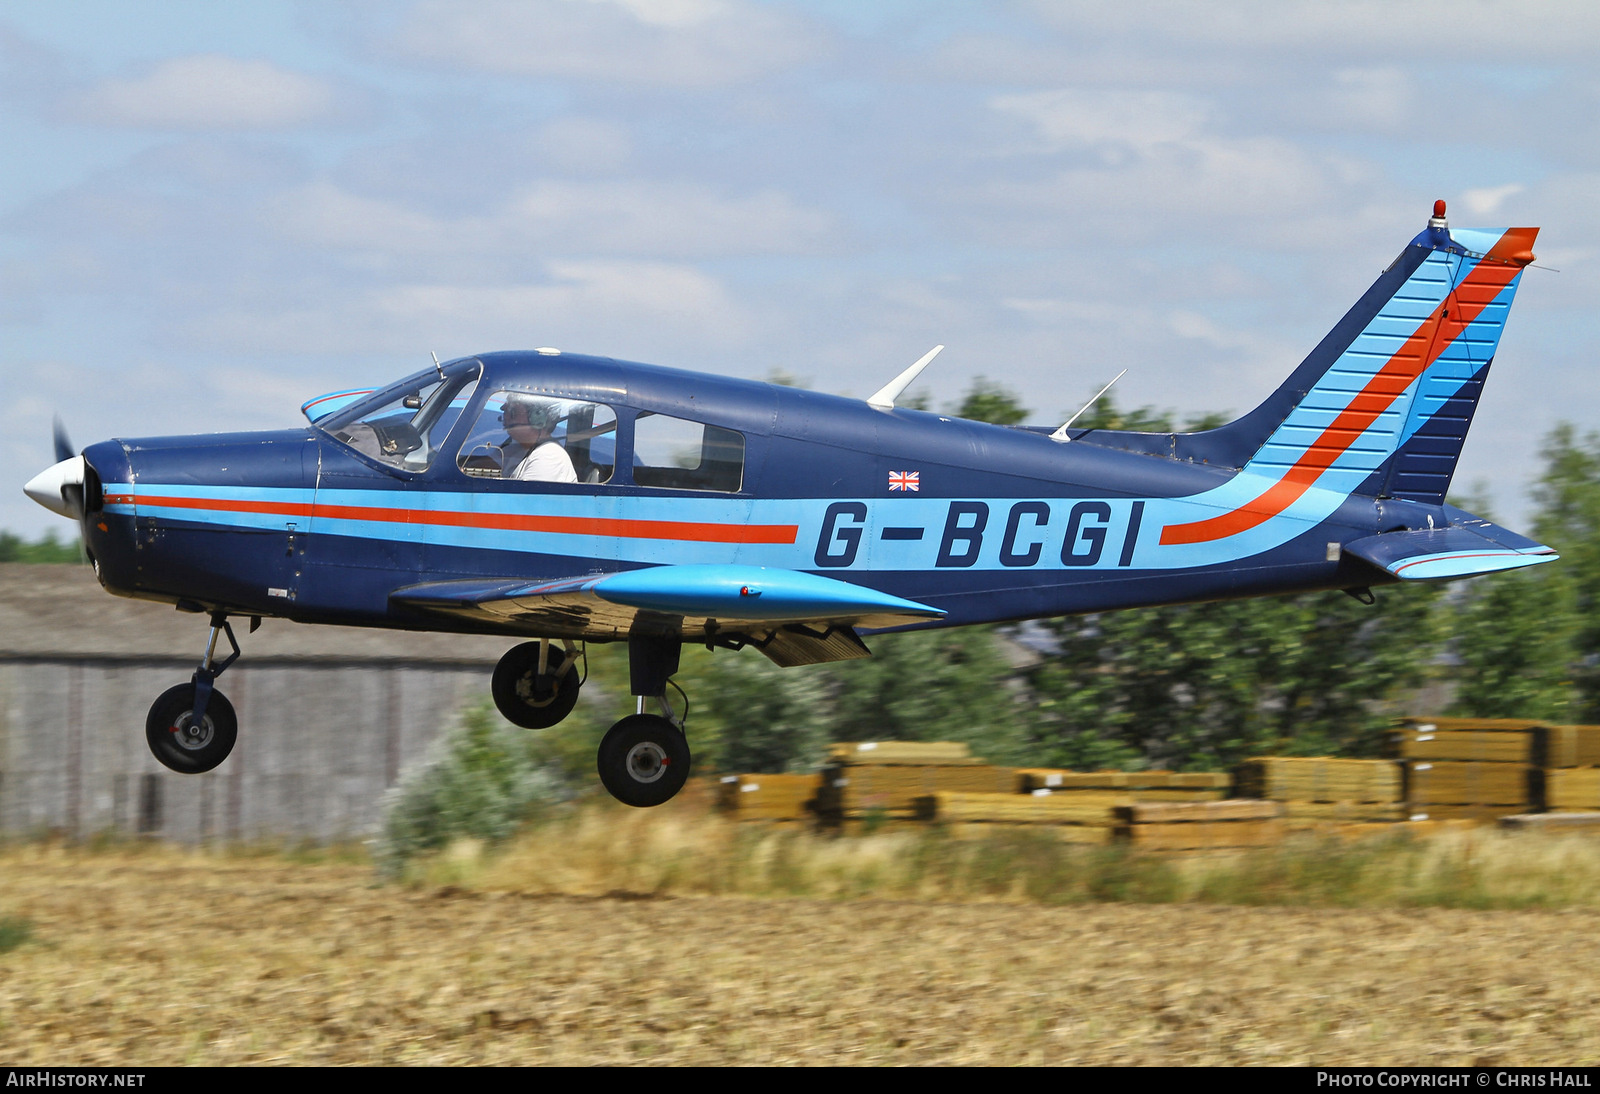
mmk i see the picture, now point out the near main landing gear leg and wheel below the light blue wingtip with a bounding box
[595,637,690,806]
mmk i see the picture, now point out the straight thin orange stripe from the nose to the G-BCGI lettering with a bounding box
[138,494,800,544]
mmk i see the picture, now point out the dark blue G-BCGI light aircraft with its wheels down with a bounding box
[26,202,1555,806]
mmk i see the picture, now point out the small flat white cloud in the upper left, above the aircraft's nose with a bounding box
[69,53,336,130]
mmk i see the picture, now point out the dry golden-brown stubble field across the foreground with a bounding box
[0,848,1600,1067]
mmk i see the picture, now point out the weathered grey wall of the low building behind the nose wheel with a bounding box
[0,654,491,843]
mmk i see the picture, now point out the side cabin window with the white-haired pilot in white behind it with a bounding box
[456,390,616,483]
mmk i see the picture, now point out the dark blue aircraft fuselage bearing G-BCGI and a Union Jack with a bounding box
[72,353,1445,638]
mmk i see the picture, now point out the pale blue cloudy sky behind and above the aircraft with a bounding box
[0,0,1600,536]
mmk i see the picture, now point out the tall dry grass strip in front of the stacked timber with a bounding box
[438,805,1600,910]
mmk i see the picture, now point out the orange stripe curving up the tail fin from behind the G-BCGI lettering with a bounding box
[1162,229,1539,544]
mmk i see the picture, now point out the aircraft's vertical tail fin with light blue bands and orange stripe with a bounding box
[1162,202,1539,542]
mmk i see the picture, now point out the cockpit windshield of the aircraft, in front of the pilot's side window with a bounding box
[317,358,483,472]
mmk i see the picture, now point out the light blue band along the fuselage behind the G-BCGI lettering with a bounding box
[109,483,1376,573]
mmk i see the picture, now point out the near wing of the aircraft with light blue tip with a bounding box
[389,566,944,665]
